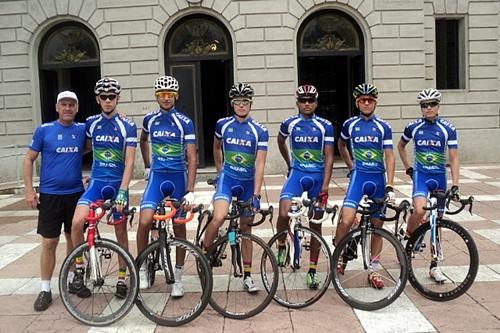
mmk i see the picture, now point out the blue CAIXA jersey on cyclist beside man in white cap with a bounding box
[86,114,137,181]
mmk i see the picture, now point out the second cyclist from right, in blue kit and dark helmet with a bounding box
[335,83,395,289]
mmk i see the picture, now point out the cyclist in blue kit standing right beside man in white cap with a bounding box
[69,77,137,298]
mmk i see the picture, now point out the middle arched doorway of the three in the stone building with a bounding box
[165,14,233,167]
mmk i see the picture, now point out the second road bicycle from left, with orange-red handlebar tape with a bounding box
[136,199,213,326]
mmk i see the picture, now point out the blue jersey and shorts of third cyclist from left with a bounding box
[214,116,269,202]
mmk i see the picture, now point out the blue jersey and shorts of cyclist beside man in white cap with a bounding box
[78,114,137,206]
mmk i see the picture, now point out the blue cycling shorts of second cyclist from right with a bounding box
[343,170,385,218]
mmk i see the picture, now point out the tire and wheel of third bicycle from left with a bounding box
[208,233,278,319]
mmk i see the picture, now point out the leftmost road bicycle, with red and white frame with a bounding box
[59,201,138,326]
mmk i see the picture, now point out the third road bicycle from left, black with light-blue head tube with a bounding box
[196,180,278,319]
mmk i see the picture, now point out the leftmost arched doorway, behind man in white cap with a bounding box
[38,22,100,167]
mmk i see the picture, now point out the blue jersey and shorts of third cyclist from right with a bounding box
[279,114,334,200]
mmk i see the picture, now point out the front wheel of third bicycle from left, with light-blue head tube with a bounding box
[208,233,278,319]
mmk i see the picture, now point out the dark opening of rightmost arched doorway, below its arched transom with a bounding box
[299,56,364,154]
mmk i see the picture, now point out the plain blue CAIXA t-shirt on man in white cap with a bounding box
[29,120,85,195]
